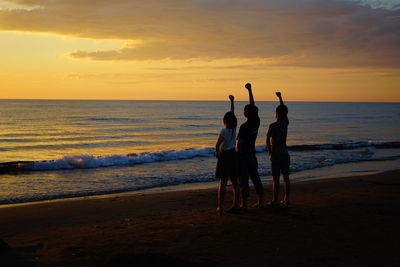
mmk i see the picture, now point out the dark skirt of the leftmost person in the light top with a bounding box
[215,149,239,178]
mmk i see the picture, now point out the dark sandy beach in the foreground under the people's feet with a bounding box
[0,171,400,266]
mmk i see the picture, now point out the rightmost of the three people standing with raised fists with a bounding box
[267,92,290,206]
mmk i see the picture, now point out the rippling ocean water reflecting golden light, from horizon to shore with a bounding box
[0,100,400,204]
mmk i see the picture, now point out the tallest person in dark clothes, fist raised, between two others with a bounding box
[237,83,264,209]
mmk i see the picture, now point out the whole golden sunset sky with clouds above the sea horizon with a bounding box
[0,0,400,102]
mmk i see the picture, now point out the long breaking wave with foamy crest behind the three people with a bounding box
[0,141,400,173]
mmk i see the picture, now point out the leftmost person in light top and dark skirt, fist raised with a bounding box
[215,95,240,215]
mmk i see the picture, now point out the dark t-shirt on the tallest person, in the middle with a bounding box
[237,116,260,155]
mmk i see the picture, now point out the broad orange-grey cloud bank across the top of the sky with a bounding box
[0,0,400,68]
